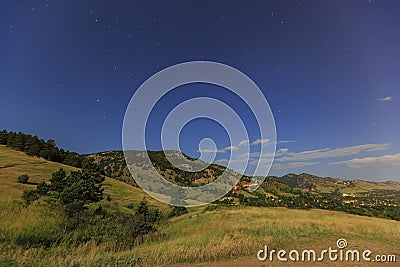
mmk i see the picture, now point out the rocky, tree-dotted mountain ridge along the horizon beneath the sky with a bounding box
[89,150,400,193]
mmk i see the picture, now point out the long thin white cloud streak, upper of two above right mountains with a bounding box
[276,144,389,162]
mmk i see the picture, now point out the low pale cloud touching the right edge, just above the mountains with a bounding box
[329,153,400,168]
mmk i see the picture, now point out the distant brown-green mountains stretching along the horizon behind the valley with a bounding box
[87,150,400,194]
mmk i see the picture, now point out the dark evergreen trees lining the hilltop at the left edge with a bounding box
[0,130,84,168]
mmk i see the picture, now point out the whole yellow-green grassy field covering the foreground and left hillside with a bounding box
[0,146,400,266]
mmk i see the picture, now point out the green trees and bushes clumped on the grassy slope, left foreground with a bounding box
[18,164,163,250]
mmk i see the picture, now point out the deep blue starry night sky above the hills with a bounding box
[0,0,400,181]
